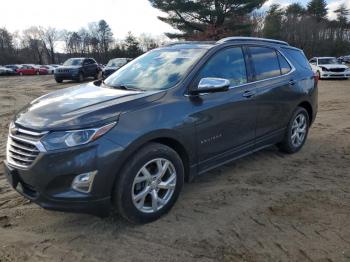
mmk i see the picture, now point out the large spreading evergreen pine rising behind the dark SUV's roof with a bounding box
[149,0,266,39]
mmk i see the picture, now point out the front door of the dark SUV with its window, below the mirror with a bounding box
[192,46,256,172]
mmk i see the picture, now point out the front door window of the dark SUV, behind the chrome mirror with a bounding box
[198,47,247,85]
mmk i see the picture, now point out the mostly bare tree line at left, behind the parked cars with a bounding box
[0,20,164,65]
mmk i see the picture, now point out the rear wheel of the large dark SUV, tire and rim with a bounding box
[278,107,310,154]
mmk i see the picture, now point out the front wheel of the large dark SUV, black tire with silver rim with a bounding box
[112,143,184,224]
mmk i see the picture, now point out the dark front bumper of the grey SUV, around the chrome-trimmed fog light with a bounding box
[4,138,123,216]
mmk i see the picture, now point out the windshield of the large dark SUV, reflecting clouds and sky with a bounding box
[105,48,206,90]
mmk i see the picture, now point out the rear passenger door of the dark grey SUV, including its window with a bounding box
[248,46,295,147]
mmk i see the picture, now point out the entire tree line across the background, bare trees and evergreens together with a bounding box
[0,0,350,64]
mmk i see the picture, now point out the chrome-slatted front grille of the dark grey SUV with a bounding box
[6,127,47,168]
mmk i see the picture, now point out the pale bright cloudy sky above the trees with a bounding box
[0,0,350,39]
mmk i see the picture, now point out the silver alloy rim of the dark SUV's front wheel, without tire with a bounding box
[131,158,177,213]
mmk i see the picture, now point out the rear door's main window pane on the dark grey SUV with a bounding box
[249,47,281,80]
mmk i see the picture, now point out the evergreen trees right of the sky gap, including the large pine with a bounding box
[149,0,350,57]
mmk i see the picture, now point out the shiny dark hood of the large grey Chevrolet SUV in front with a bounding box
[15,82,164,131]
